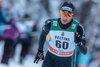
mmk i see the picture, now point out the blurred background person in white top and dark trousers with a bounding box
[16,14,35,64]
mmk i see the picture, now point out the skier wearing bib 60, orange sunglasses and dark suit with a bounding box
[34,2,87,67]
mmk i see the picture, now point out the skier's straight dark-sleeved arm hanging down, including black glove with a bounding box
[34,20,51,63]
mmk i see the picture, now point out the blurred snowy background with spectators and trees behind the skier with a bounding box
[0,0,100,67]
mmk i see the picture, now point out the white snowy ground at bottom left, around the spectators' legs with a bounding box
[0,42,42,67]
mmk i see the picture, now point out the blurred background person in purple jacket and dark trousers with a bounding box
[1,18,19,65]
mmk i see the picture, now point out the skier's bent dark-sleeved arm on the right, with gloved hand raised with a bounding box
[75,24,87,54]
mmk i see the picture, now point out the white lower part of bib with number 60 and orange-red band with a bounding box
[48,30,75,57]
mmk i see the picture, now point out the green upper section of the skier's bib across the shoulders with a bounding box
[50,18,79,32]
